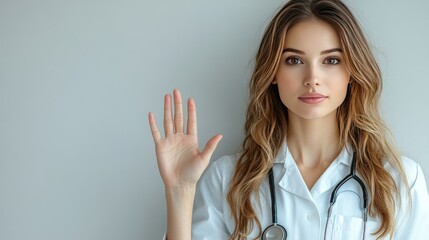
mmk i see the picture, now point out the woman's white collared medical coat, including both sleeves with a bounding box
[192,144,429,240]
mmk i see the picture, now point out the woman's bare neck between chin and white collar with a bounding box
[287,113,341,168]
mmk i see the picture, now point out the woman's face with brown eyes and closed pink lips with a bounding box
[273,19,350,120]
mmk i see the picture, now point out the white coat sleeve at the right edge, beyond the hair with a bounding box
[395,161,429,240]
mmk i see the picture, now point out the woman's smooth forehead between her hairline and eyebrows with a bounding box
[284,19,341,53]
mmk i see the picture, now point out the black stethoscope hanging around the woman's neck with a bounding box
[261,153,368,240]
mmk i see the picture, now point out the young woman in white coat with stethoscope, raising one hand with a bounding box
[149,0,429,240]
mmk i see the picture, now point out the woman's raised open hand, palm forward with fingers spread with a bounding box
[149,89,222,189]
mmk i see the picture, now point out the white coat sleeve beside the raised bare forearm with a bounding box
[192,157,231,240]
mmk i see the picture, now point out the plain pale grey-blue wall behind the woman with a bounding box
[0,0,429,240]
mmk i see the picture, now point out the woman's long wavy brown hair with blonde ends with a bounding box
[228,0,406,239]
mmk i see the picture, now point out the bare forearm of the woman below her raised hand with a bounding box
[165,187,195,240]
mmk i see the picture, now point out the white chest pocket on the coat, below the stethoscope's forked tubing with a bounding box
[326,215,377,240]
